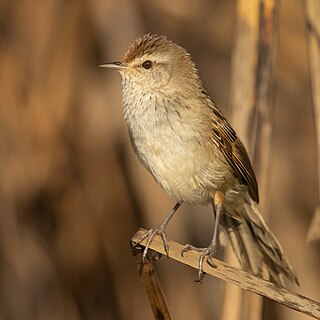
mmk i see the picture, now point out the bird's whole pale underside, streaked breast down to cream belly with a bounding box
[124,91,232,203]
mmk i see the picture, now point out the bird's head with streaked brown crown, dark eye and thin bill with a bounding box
[100,34,200,90]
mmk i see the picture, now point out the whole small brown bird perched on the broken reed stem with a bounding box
[101,34,298,285]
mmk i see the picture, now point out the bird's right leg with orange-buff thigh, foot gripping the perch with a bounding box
[181,191,224,282]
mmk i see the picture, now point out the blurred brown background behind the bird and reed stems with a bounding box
[0,0,320,320]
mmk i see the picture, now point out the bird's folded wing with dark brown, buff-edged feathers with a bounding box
[204,92,259,203]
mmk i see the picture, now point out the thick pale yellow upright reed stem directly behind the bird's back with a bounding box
[226,0,259,320]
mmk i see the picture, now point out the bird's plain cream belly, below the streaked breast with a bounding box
[129,121,228,204]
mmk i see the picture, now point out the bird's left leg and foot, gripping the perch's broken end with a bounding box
[135,202,182,262]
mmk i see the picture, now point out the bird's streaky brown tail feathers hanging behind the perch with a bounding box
[222,199,299,286]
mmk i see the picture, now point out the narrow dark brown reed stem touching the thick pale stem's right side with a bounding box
[252,0,280,210]
